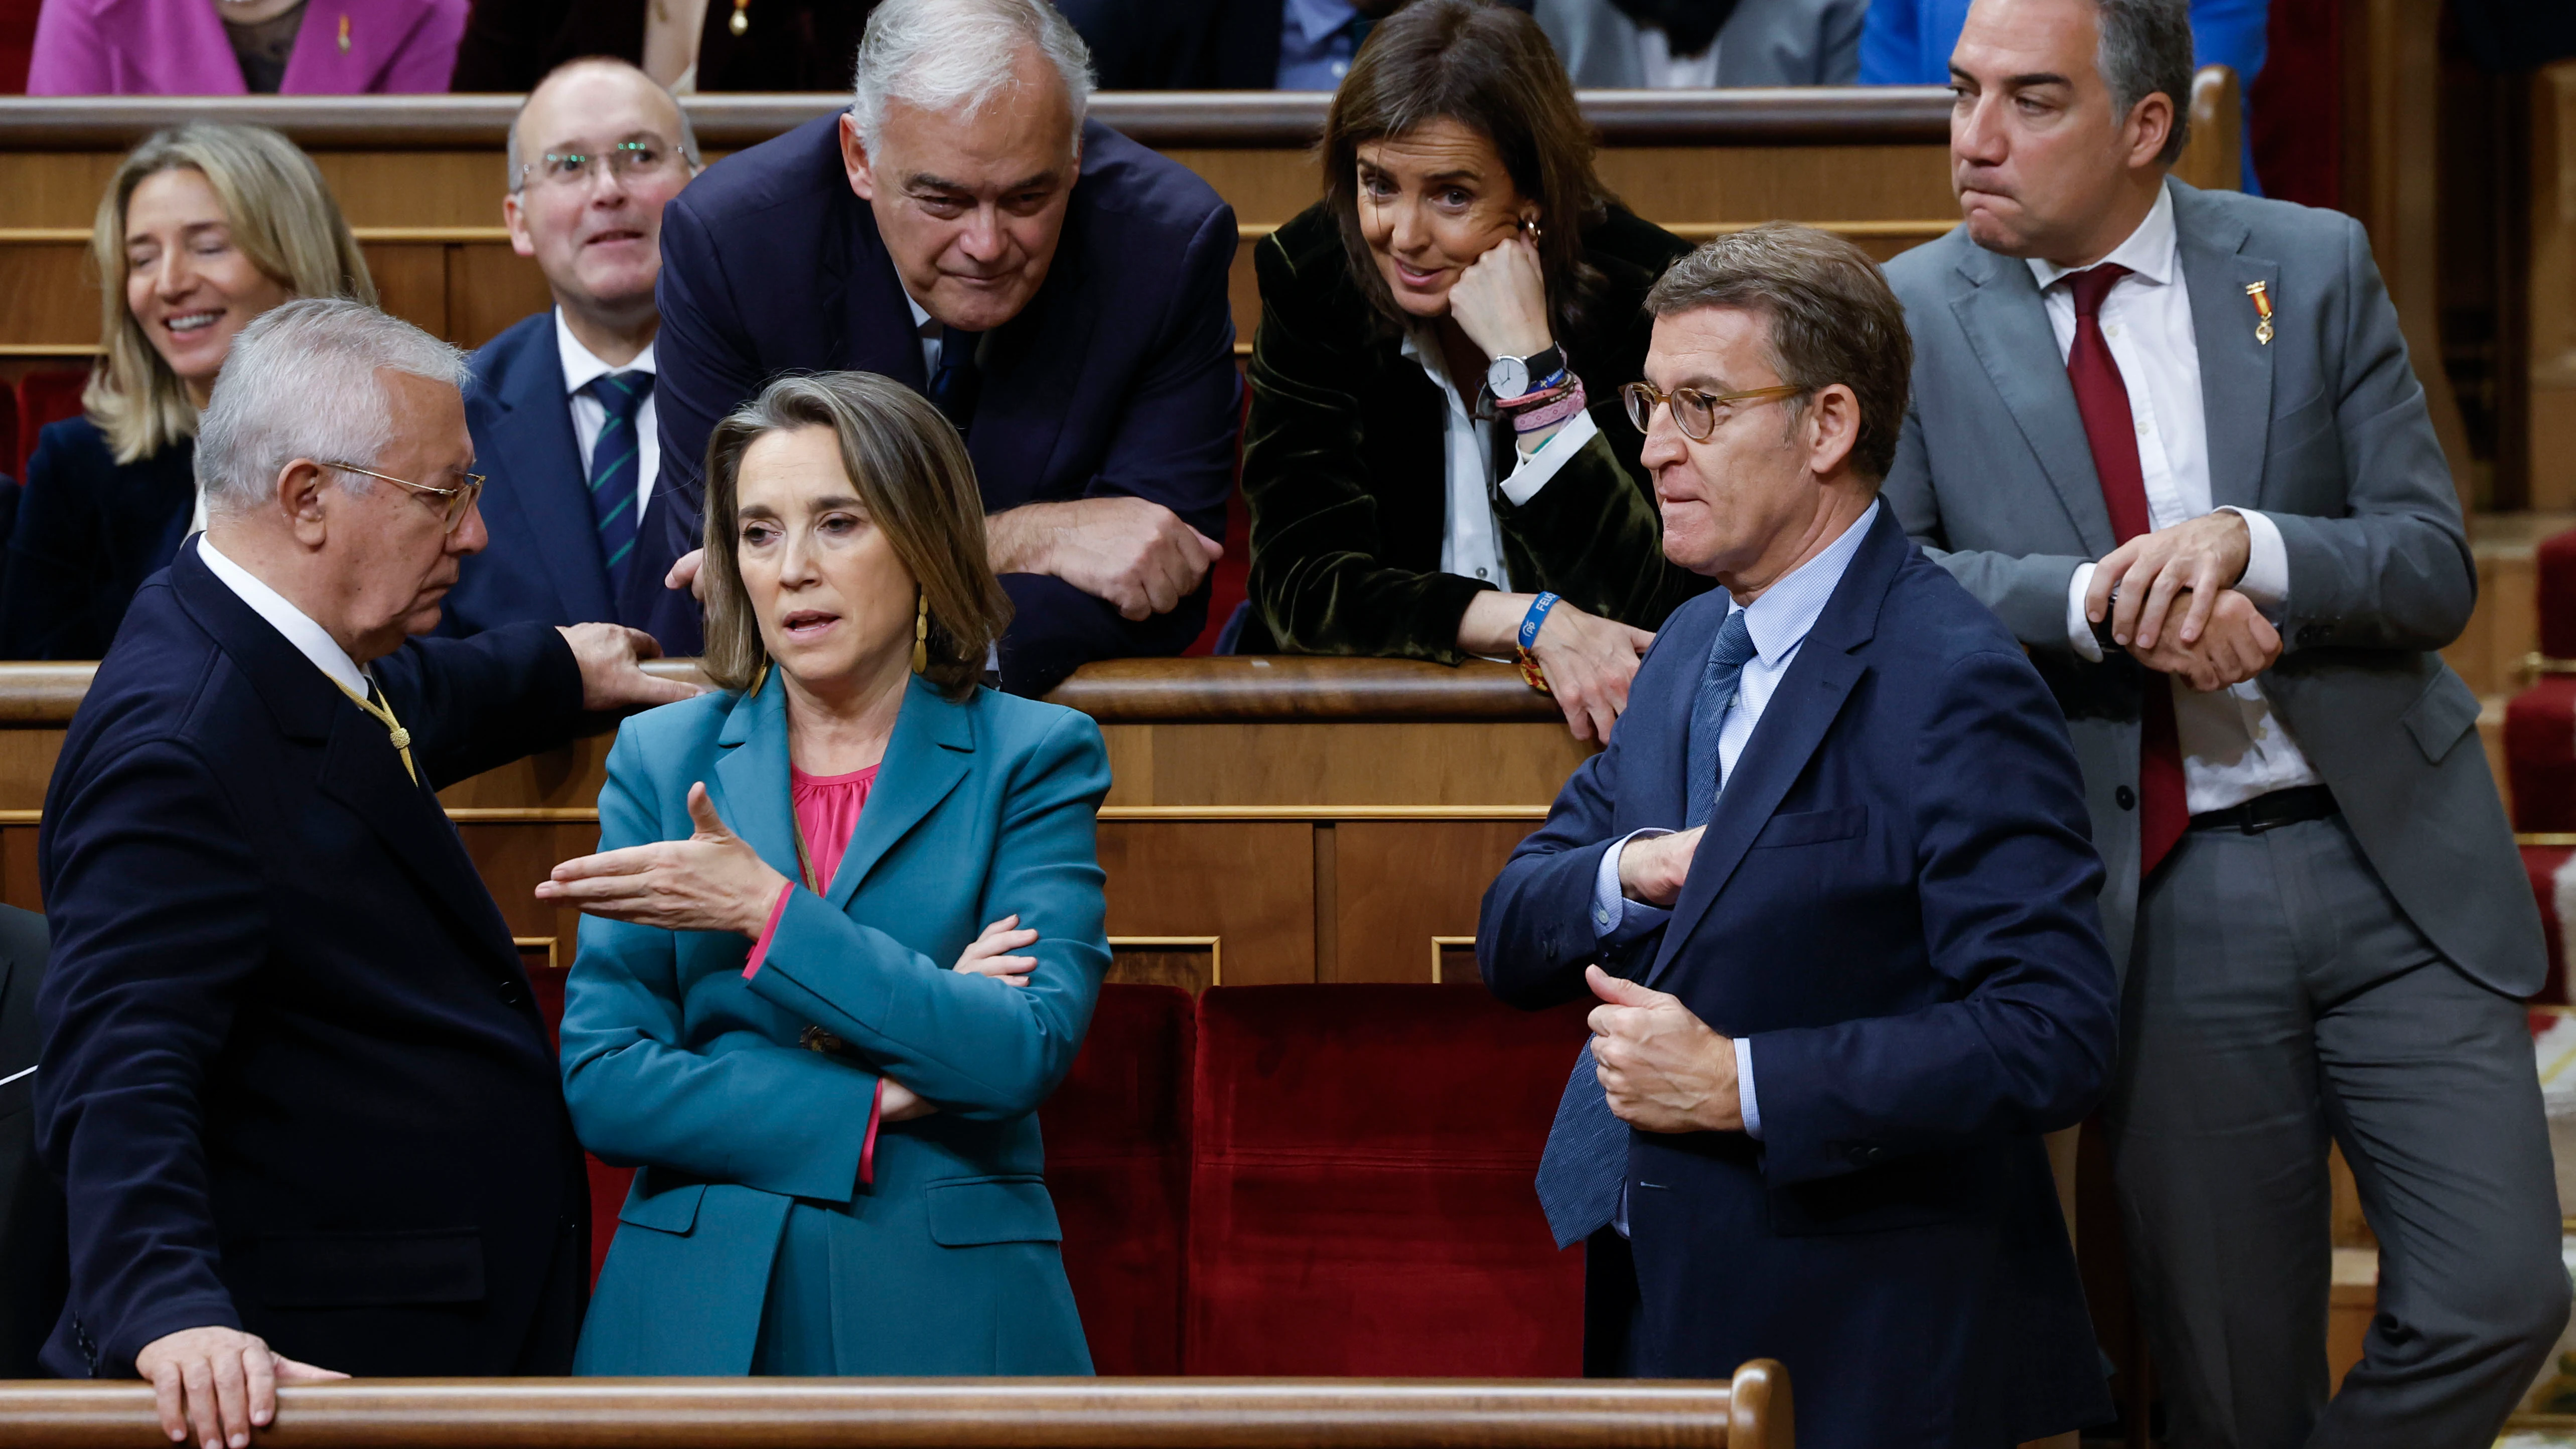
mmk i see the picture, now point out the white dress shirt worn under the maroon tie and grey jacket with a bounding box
[2030,188,2319,816]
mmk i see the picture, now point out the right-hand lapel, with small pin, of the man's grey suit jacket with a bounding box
[2167,180,2290,507]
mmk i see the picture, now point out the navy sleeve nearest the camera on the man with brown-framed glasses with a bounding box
[1749,654,2117,1184]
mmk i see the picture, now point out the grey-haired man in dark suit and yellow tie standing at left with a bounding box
[36,299,695,1449]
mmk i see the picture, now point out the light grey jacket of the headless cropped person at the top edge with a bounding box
[1530,0,1870,90]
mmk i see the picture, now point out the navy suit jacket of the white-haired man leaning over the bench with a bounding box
[649,113,1242,695]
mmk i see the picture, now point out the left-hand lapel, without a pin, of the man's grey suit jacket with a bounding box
[1950,244,2115,556]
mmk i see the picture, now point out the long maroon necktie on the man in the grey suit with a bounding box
[2066,262,2192,875]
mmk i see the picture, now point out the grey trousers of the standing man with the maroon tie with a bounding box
[2110,816,2568,1449]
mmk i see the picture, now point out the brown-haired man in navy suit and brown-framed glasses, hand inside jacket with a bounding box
[1476,226,2115,1449]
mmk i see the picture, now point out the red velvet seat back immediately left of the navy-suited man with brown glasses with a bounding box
[1185,986,1584,1377]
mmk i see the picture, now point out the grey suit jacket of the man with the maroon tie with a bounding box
[1886,180,2548,996]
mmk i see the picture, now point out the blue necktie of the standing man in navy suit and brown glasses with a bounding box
[1538,610,1754,1248]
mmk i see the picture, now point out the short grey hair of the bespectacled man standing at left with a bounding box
[196,296,472,515]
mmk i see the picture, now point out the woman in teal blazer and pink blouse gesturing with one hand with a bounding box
[538,373,1110,1374]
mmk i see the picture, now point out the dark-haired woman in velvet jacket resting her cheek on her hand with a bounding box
[1236,0,1708,739]
